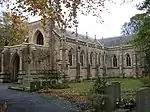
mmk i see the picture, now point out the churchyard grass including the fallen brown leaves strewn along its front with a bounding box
[39,78,143,110]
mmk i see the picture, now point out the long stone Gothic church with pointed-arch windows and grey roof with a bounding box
[0,21,145,83]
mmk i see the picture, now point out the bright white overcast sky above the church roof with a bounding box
[0,0,143,39]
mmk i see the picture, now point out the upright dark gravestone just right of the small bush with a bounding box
[105,82,121,112]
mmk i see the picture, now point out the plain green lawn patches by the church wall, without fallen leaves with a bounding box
[70,78,143,92]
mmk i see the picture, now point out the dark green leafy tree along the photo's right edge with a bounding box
[133,0,150,69]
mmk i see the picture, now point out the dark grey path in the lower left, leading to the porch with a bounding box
[0,84,74,112]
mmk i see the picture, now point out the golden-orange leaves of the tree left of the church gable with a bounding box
[3,12,28,45]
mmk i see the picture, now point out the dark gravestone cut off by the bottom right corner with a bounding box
[136,88,150,112]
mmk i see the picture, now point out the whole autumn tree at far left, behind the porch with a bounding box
[0,12,28,46]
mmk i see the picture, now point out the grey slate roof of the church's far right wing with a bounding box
[98,35,133,47]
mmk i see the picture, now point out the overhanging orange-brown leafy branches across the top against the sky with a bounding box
[1,0,112,28]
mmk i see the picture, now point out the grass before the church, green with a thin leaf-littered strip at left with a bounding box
[39,78,143,102]
